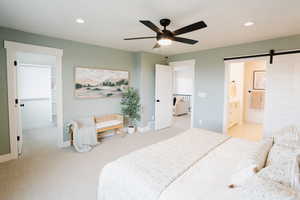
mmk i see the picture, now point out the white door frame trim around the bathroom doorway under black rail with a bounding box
[222,56,270,135]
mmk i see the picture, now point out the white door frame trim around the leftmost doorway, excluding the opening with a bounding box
[4,41,64,159]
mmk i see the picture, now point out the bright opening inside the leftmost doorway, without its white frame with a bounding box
[16,52,57,156]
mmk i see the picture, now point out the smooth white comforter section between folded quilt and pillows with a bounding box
[159,138,255,200]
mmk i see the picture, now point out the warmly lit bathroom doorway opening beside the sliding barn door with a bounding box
[223,59,267,141]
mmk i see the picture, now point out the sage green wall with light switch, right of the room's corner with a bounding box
[169,35,300,132]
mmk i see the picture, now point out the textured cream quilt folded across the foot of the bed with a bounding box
[98,129,229,200]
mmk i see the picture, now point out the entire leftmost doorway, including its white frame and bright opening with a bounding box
[4,41,64,159]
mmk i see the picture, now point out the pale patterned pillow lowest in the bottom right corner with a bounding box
[236,176,299,200]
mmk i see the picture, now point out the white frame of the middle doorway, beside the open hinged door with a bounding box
[169,59,196,128]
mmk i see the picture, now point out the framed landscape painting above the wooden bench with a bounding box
[75,67,129,98]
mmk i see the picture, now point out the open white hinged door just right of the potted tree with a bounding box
[155,65,173,130]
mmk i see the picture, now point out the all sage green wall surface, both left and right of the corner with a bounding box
[0,27,300,155]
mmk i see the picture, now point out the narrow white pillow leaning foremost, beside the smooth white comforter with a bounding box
[229,139,273,188]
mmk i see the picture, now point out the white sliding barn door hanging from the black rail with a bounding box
[264,54,300,135]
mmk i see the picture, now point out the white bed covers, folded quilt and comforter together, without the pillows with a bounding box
[98,129,300,200]
